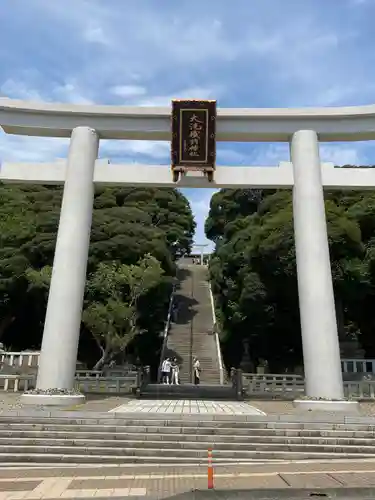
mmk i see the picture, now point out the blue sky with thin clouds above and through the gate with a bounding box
[0,0,375,250]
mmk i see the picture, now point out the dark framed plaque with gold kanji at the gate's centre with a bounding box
[171,100,216,180]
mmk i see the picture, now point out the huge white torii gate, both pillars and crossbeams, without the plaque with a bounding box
[0,98,375,409]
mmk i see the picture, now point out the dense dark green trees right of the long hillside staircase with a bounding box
[206,174,375,372]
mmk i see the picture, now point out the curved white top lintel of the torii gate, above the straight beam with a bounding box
[0,97,375,142]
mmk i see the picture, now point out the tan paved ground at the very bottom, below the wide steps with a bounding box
[0,461,375,500]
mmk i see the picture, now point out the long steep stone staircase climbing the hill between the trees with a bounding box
[165,259,220,385]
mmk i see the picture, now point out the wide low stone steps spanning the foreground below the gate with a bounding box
[0,412,375,466]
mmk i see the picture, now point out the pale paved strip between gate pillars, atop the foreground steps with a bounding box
[110,400,265,415]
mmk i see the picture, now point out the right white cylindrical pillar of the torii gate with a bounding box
[291,130,344,400]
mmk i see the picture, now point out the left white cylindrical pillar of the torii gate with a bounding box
[24,127,99,404]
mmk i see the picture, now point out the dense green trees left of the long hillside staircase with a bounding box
[0,184,195,376]
